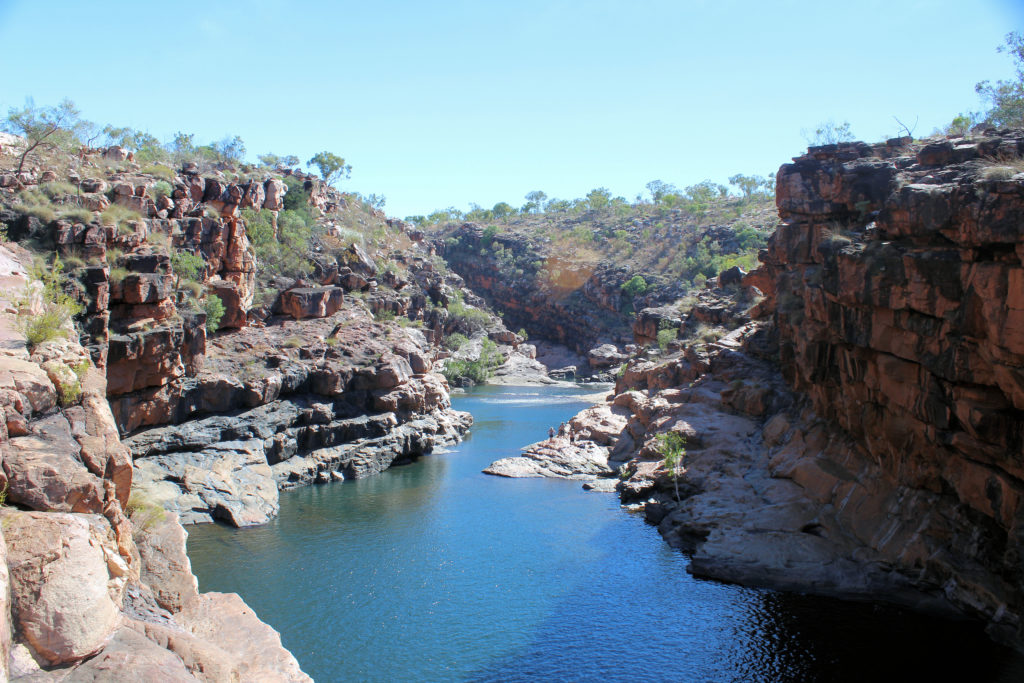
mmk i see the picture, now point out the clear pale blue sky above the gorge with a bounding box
[0,0,1024,217]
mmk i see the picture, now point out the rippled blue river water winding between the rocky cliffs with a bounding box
[188,387,1024,682]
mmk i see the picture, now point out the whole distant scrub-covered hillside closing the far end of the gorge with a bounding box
[420,176,775,354]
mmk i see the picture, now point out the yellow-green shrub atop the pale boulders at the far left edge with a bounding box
[16,255,82,350]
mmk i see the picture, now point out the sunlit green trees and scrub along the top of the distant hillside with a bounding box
[415,174,774,298]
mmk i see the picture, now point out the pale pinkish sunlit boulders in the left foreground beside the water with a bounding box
[0,248,309,682]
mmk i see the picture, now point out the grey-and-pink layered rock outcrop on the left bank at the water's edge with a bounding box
[123,309,471,526]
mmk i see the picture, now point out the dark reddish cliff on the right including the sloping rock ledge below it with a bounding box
[512,131,1024,646]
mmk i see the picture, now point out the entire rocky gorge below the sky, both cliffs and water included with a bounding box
[0,111,1024,681]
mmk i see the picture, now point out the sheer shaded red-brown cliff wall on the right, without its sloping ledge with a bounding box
[756,131,1024,642]
